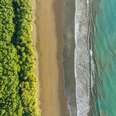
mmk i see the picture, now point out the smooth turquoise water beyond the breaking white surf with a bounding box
[92,0,116,116]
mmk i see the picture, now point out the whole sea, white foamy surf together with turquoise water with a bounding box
[75,0,116,116]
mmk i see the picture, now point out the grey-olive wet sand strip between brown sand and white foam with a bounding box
[63,0,77,116]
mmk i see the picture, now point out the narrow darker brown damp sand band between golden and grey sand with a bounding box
[53,0,69,116]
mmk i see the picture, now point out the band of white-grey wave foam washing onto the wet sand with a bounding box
[74,0,93,116]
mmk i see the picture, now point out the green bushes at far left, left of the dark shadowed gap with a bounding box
[0,0,22,116]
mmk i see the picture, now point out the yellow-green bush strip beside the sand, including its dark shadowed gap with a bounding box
[13,0,39,116]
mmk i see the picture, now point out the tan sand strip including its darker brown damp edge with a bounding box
[33,0,67,116]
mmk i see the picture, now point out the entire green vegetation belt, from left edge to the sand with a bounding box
[0,0,40,116]
